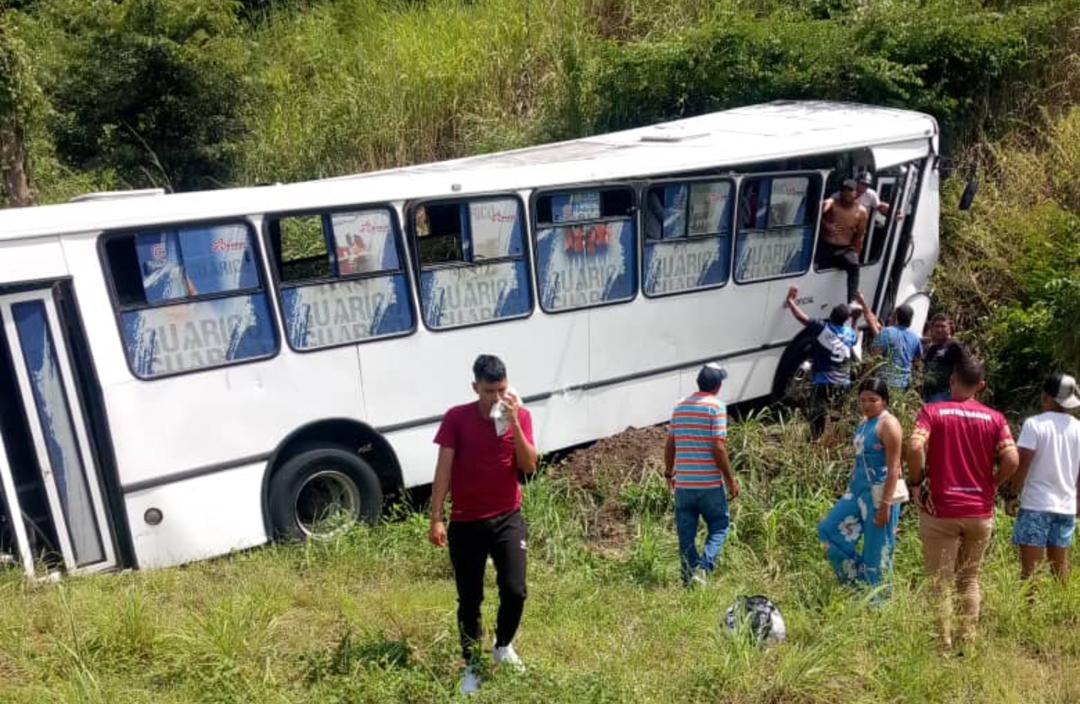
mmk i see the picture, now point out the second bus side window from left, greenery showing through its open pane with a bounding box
[270,207,416,351]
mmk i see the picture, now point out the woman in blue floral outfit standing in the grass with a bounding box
[818,378,904,586]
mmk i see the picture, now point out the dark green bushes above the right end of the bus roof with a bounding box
[574,1,1069,141]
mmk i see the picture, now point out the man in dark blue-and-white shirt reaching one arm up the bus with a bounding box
[785,286,859,439]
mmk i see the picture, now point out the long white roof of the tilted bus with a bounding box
[0,100,937,241]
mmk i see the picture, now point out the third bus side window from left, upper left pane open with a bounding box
[411,197,532,330]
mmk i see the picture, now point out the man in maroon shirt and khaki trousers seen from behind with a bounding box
[907,358,1020,648]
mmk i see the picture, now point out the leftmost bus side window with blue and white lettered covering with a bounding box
[103,222,278,379]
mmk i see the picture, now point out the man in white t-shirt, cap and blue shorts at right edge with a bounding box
[1013,374,1080,582]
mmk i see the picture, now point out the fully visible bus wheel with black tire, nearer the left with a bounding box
[268,446,382,540]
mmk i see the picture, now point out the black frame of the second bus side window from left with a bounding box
[262,202,419,354]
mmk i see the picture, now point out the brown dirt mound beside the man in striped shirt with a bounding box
[552,427,667,554]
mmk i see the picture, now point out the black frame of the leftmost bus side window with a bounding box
[96,215,282,383]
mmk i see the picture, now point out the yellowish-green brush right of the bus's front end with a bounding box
[934,108,1080,412]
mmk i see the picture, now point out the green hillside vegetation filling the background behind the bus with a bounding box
[6,0,1080,408]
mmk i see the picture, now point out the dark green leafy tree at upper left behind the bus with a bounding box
[23,0,253,189]
